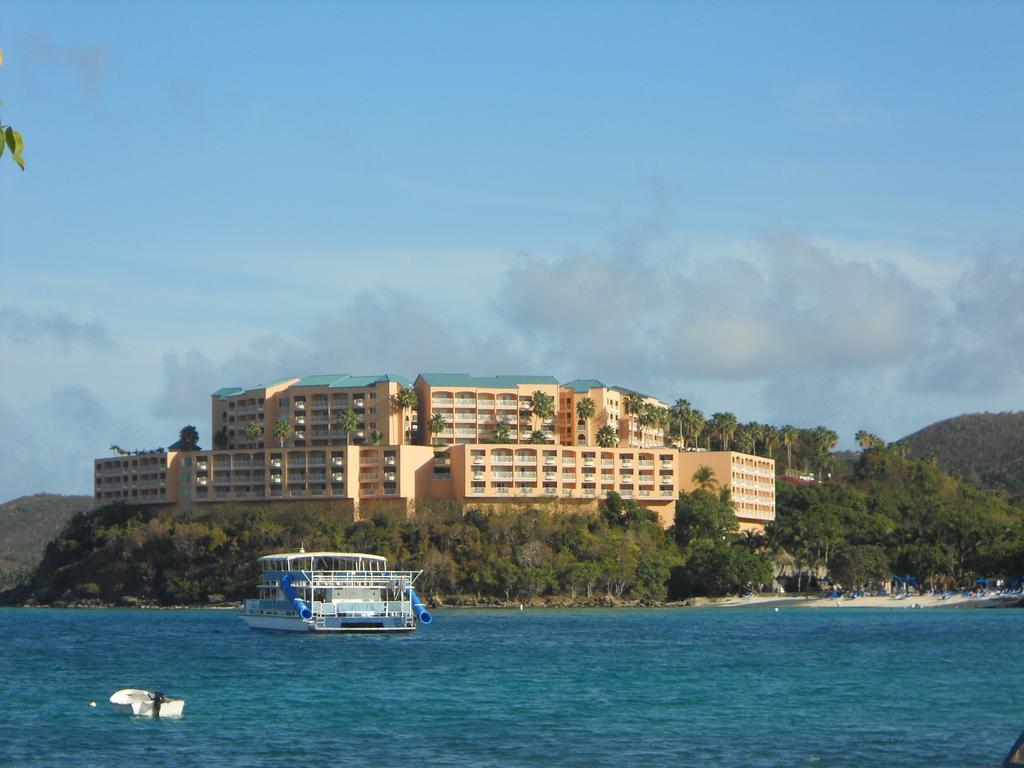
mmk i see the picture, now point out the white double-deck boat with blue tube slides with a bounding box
[242,549,431,632]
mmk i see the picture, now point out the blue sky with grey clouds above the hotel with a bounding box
[0,2,1024,498]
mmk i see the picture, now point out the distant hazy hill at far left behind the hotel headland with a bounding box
[0,494,92,590]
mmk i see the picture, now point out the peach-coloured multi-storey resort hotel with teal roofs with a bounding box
[94,374,775,530]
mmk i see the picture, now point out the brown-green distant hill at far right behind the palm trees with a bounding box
[903,411,1024,504]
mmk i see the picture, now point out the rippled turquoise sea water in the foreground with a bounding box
[0,607,1024,767]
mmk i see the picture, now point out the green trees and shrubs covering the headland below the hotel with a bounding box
[6,442,1024,607]
